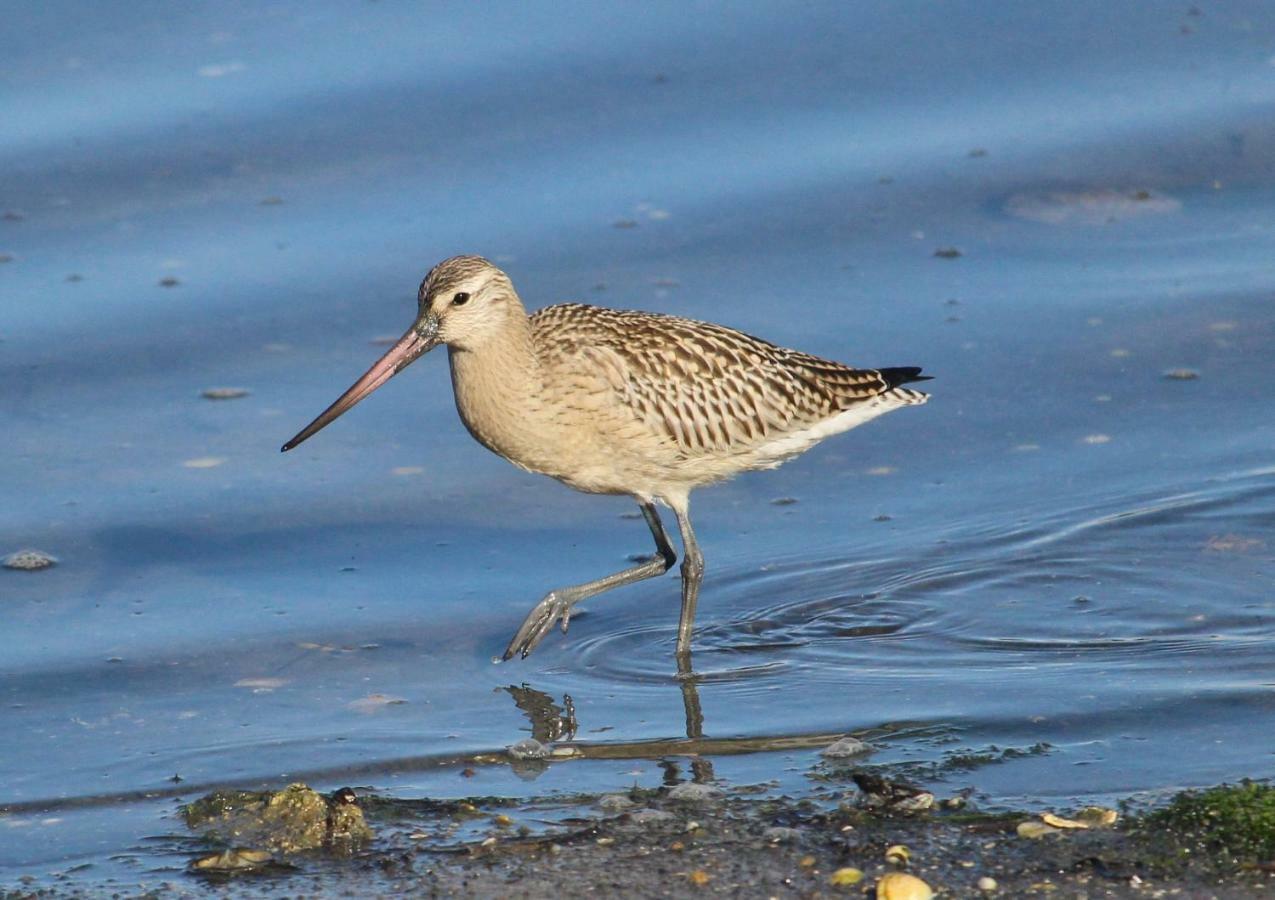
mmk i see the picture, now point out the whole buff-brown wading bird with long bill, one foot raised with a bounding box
[283,256,928,662]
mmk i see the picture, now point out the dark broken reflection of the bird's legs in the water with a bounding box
[500,647,714,785]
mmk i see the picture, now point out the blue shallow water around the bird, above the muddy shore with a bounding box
[0,3,1275,877]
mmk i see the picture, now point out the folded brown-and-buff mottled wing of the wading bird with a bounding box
[532,303,890,455]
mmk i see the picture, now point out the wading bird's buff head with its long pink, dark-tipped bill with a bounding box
[283,256,515,451]
